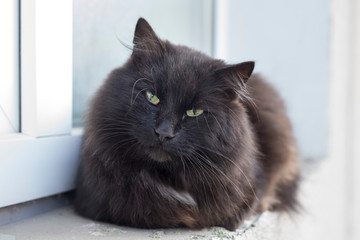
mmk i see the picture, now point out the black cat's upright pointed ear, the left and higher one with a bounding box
[133,18,162,51]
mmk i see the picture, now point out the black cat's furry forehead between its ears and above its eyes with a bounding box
[136,44,223,105]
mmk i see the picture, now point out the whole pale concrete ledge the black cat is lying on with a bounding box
[0,161,334,240]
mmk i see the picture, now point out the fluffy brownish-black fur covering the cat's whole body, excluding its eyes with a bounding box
[75,18,299,230]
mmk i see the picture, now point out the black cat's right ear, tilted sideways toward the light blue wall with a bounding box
[216,61,255,83]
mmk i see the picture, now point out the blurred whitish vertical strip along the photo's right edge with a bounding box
[330,0,360,240]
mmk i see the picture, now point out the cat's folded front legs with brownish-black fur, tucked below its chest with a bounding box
[110,162,258,229]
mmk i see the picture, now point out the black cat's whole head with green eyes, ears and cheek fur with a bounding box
[93,18,254,165]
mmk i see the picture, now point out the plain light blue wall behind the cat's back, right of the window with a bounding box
[227,0,330,158]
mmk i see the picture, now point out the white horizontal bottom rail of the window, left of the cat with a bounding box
[0,129,82,208]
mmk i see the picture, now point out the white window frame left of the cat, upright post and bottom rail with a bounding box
[0,0,81,207]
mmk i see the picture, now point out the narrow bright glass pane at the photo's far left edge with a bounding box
[0,1,19,134]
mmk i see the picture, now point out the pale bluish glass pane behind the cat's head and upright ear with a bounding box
[73,0,212,126]
